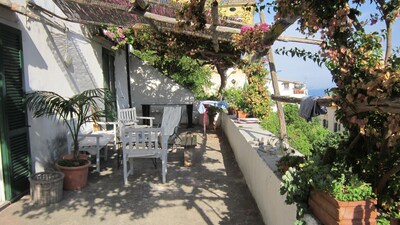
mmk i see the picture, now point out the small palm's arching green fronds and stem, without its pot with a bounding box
[26,89,113,166]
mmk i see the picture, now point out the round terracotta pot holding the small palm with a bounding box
[56,160,90,191]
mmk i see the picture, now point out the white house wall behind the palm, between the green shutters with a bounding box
[0,1,127,174]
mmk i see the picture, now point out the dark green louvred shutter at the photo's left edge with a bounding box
[0,24,31,200]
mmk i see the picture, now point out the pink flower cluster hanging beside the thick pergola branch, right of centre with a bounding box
[232,23,270,53]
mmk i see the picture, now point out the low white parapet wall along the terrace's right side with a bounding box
[221,113,296,225]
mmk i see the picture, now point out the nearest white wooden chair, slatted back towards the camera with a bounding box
[121,126,168,185]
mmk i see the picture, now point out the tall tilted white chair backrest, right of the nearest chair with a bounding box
[161,106,181,136]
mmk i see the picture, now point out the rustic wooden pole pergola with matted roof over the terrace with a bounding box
[0,0,324,140]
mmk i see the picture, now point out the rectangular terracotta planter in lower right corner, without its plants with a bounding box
[308,192,377,225]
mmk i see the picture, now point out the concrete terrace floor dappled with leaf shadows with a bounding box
[0,128,263,225]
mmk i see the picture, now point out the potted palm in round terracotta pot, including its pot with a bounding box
[26,89,112,190]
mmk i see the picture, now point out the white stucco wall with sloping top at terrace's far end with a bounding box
[130,56,196,123]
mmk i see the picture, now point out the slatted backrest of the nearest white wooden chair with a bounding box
[121,126,167,157]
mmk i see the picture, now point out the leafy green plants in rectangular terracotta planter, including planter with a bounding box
[281,136,377,225]
